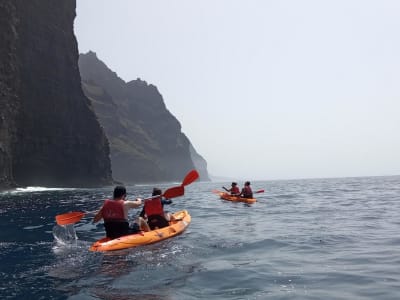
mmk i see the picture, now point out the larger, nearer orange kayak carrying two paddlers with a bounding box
[89,210,191,251]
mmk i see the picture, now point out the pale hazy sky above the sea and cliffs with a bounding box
[74,0,400,180]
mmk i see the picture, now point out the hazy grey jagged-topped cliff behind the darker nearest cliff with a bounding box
[79,52,208,183]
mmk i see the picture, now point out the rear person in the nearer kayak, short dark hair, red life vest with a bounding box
[93,185,148,239]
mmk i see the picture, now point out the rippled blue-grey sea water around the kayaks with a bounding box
[0,176,400,300]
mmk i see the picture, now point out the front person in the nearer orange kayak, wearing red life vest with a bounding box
[140,188,174,230]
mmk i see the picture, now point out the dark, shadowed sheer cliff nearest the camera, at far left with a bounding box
[0,0,112,186]
